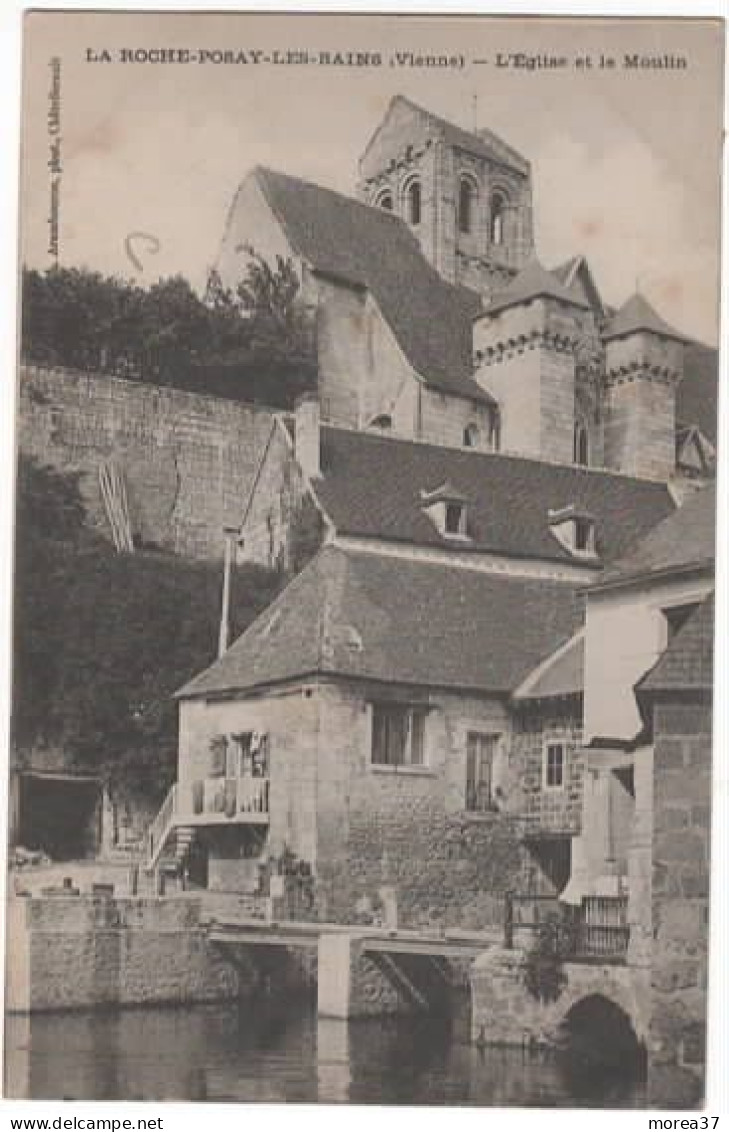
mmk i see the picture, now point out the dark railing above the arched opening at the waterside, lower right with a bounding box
[504,892,631,962]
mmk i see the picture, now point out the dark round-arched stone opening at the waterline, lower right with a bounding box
[557,994,646,1103]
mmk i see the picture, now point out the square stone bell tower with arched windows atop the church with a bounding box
[359,96,533,294]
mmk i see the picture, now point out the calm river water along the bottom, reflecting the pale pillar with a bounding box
[6,997,644,1107]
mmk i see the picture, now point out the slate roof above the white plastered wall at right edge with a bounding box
[595,483,717,588]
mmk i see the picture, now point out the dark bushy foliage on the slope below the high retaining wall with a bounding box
[12,456,280,795]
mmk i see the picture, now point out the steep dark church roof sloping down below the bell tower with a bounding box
[254,166,492,404]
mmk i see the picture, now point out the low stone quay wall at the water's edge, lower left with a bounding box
[6,897,257,1013]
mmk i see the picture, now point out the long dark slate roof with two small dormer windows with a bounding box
[315,426,675,566]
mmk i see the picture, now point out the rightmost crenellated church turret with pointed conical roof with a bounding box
[602,294,685,480]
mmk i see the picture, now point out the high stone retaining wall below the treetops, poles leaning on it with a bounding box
[17,366,273,559]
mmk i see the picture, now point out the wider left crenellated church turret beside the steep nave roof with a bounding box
[473,259,588,463]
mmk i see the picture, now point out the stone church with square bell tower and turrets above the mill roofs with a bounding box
[217,96,715,482]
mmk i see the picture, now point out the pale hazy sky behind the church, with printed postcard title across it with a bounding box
[20,11,722,344]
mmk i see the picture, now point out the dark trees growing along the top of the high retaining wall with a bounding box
[20,248,316,409]
